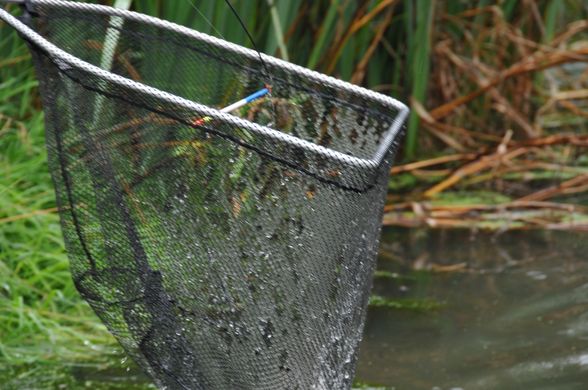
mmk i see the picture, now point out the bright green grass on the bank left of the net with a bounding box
[0,103,127,388]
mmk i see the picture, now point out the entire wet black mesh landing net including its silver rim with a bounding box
[0,0,407,389]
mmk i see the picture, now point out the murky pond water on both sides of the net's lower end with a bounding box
[0,229,588,390]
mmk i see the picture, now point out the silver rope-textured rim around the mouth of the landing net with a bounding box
[0,0,409,171]
